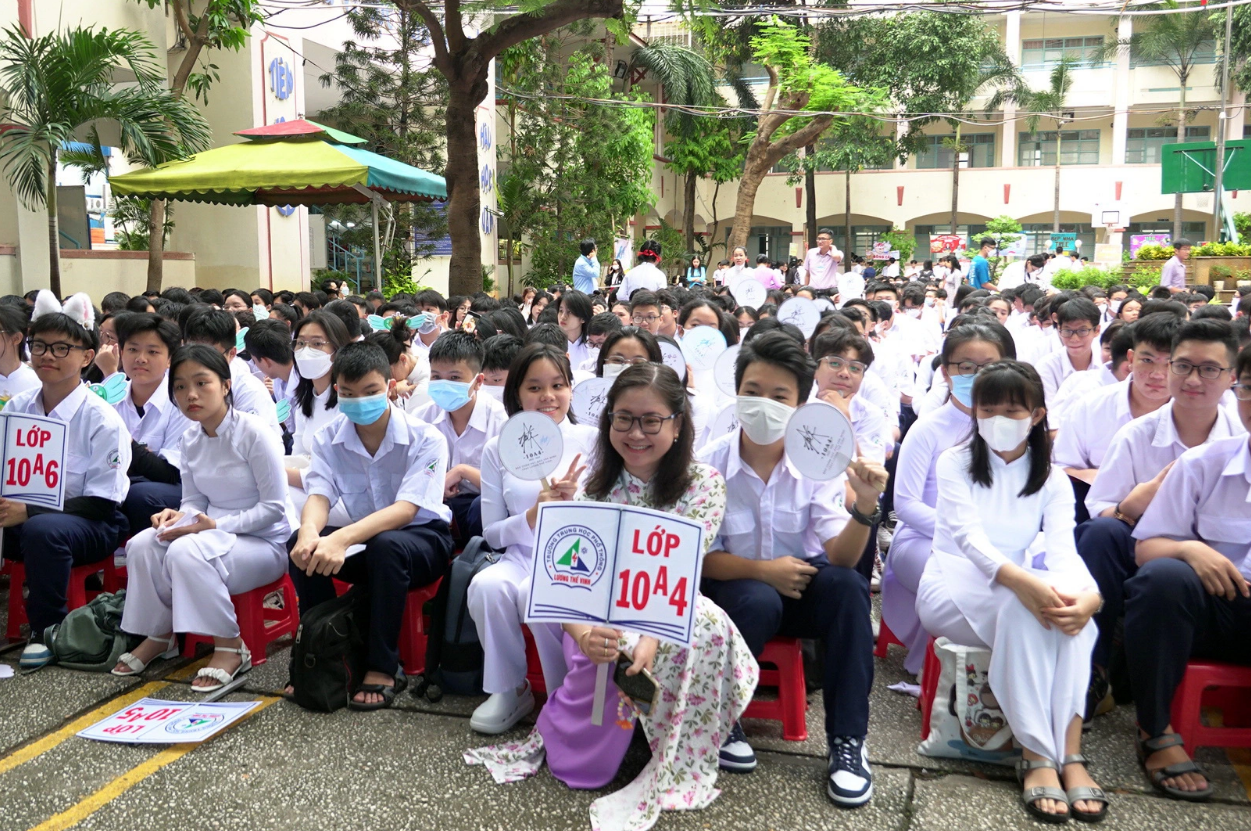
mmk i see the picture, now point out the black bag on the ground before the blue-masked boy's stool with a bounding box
[291,587,369,712]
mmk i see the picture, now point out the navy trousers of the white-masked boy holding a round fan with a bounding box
[699,557,873,738]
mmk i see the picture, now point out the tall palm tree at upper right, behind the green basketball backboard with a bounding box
[1096,0,1223,239]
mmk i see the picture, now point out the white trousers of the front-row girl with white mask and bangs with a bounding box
[915,568,1098,765]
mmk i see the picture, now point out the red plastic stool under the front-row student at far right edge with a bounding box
[1172,661,1251,756]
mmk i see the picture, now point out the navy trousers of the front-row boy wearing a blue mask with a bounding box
[286,522,452,677]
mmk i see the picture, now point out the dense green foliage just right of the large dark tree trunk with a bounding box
[499,36,656,285]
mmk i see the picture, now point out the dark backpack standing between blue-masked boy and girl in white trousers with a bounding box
[413,537,499,701]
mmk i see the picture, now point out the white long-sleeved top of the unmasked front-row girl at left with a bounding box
[178,407,292,543]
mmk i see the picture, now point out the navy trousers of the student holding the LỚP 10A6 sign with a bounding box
[4,511,126,641]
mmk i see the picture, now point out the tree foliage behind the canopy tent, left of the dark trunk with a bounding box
[317,6,448,285]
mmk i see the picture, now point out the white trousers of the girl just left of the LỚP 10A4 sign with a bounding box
[467,548,565,695]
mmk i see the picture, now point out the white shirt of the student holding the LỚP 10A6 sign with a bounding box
[4,384,130,503]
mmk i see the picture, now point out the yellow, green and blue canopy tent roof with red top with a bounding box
[109,119,448,205]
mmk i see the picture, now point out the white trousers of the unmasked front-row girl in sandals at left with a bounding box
[121,528,286,638]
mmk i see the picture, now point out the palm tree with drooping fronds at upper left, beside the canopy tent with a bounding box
[0,26,210,297]
